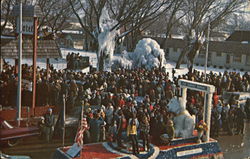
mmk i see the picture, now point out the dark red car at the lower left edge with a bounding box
[0,118,40,146]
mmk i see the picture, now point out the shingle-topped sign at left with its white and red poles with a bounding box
[12,3,42,126]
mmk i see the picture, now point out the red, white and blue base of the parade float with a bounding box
[53,137,223,159]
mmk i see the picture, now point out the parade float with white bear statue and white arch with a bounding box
[53,79,223,159]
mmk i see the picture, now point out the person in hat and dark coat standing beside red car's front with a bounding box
[44,108,55,143]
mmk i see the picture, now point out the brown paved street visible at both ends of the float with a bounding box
[2,122,250,159]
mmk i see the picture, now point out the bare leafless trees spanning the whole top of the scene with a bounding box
[1,0,249,70]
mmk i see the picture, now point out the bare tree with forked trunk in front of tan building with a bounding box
[176,0,246,71]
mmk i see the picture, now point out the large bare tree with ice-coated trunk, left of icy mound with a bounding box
[69,0,173,71]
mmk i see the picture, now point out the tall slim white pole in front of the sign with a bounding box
[17,0,23,127]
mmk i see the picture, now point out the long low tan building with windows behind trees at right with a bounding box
[149,31,250,71]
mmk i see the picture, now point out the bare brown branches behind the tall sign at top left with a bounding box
[1,0,73,36]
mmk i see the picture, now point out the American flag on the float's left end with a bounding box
[75,118,89,146]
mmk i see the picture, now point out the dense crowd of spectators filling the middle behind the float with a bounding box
[0,60,250,153]
